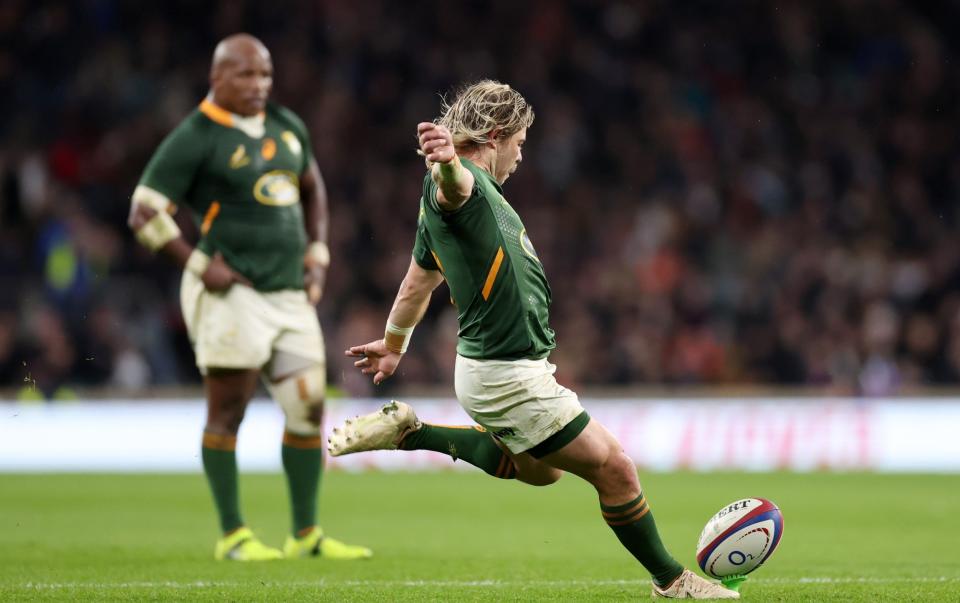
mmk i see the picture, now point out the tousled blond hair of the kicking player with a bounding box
[434,80,533,148]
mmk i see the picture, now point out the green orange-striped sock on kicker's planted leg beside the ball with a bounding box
[600,492,683,586]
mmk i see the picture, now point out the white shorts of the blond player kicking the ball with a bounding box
[454,356,583,454]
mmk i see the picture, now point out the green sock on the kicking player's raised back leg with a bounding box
[400,423,517,479]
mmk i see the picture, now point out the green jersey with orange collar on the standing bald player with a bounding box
[140,100,312,291]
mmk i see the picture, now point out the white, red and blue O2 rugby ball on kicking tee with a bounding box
[697,498,783,579]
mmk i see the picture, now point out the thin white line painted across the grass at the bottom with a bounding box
[20,576,960,590]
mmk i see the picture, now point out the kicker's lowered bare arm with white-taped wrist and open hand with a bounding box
[344,259,443,385]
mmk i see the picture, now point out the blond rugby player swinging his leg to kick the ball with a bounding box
[330,80,739,599]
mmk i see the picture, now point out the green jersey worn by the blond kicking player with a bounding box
[413,158,556,360]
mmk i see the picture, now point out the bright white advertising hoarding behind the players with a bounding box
[0,398,960,473]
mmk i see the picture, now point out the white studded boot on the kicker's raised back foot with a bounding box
[327,400,423,456]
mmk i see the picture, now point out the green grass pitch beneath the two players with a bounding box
[0,472,960,602]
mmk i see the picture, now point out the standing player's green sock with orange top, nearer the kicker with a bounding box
[280,431,323,536]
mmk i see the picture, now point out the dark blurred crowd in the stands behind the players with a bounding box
[0,0,960,397]
